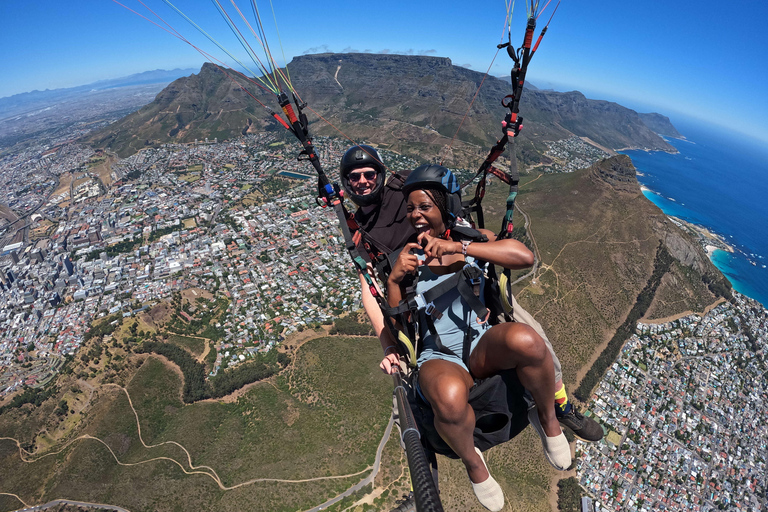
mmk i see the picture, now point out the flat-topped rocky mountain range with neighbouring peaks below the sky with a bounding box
[82,53,679,165]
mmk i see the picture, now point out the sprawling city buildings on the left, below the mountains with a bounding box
[0,135,420,394]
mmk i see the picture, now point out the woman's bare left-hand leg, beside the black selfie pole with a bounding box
[419,359,488,483]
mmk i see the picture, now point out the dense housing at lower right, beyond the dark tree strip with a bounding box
[577,293,768,512]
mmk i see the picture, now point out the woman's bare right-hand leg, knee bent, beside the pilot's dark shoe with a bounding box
[469,322,562,437]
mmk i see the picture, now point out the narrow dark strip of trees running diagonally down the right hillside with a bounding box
[574,245,675,402]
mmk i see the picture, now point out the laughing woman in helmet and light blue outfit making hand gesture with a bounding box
[381,165,571,510]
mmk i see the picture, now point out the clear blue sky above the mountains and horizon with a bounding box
[0,0,768,142]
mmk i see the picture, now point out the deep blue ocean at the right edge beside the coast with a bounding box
[622,119,768,307]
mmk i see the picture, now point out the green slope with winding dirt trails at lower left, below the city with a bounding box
[0,338,390,512]
